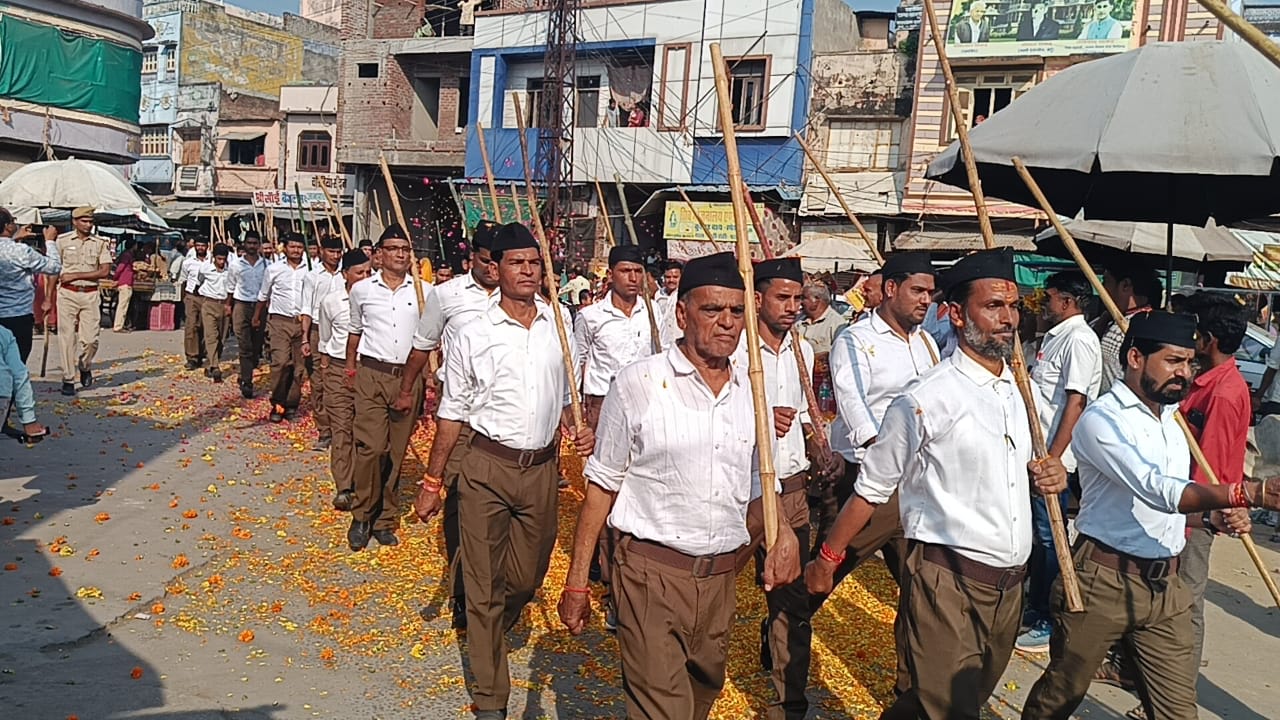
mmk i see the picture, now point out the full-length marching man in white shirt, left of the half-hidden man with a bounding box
[344,224,434,552]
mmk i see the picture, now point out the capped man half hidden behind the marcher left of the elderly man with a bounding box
[398,220,500,628]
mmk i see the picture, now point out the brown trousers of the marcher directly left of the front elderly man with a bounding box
[457,447,559,710]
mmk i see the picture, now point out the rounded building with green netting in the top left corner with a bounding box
[0,0,152,179]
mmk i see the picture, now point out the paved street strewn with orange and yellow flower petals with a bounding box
[0,332,1280,720]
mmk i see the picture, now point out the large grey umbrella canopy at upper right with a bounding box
[925,41,1280,225]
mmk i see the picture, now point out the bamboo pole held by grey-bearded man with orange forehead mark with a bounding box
[924,0,1084,612]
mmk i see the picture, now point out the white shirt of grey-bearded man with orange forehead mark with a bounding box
[854,350,1032,568]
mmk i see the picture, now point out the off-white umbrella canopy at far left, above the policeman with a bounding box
[0,159,145,211]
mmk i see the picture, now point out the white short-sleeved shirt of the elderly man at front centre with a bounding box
[582,346,755,556]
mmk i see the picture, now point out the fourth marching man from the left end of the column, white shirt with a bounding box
[253,232,307,423]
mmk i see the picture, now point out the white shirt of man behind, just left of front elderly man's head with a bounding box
[573,291,653,397]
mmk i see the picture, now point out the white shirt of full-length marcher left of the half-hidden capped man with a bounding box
[347,270,433,365]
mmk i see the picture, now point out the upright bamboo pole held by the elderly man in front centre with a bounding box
[712,42,778,548]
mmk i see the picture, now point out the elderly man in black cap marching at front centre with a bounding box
[559,252,799,719]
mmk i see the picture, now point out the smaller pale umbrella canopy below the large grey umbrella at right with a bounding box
[1036,220,1253,270]
